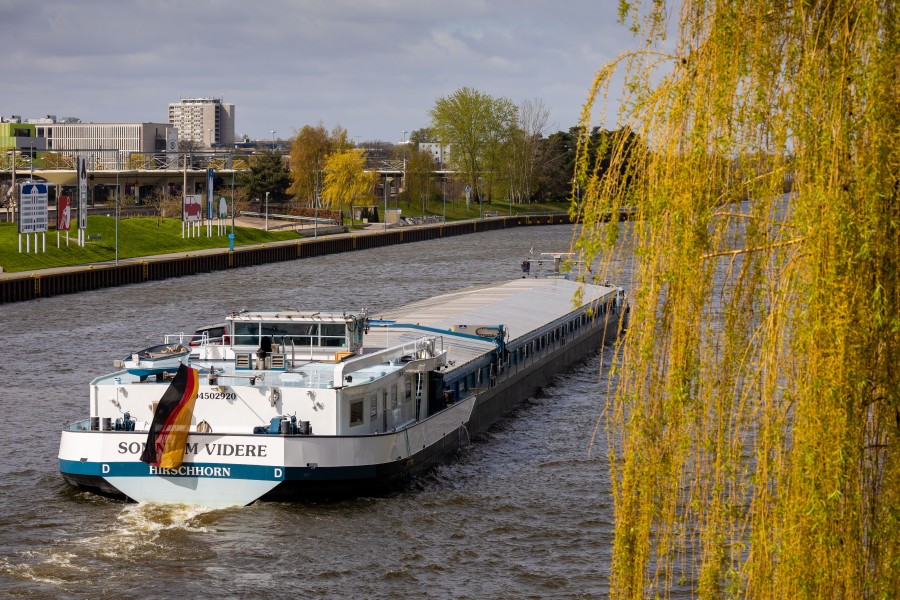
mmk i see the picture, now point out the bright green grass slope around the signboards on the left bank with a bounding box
[0,215,300,272]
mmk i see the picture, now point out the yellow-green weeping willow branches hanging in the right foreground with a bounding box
[573,0,900,598]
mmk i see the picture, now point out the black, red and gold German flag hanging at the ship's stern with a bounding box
[141,365,200,469]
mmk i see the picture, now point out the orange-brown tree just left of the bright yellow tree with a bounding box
[288,122,353,205]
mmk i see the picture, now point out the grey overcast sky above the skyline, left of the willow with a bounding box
[0,0,634,142]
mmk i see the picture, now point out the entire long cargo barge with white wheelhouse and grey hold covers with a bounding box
[59,279,627,507]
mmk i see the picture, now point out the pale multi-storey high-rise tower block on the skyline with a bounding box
[169,98,234,148]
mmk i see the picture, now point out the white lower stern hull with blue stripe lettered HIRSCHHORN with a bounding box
[59,397,475,508]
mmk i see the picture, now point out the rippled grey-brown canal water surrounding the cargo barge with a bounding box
[0,226,613,598]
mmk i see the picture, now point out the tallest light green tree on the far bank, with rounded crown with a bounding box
[429,87,517,205]
